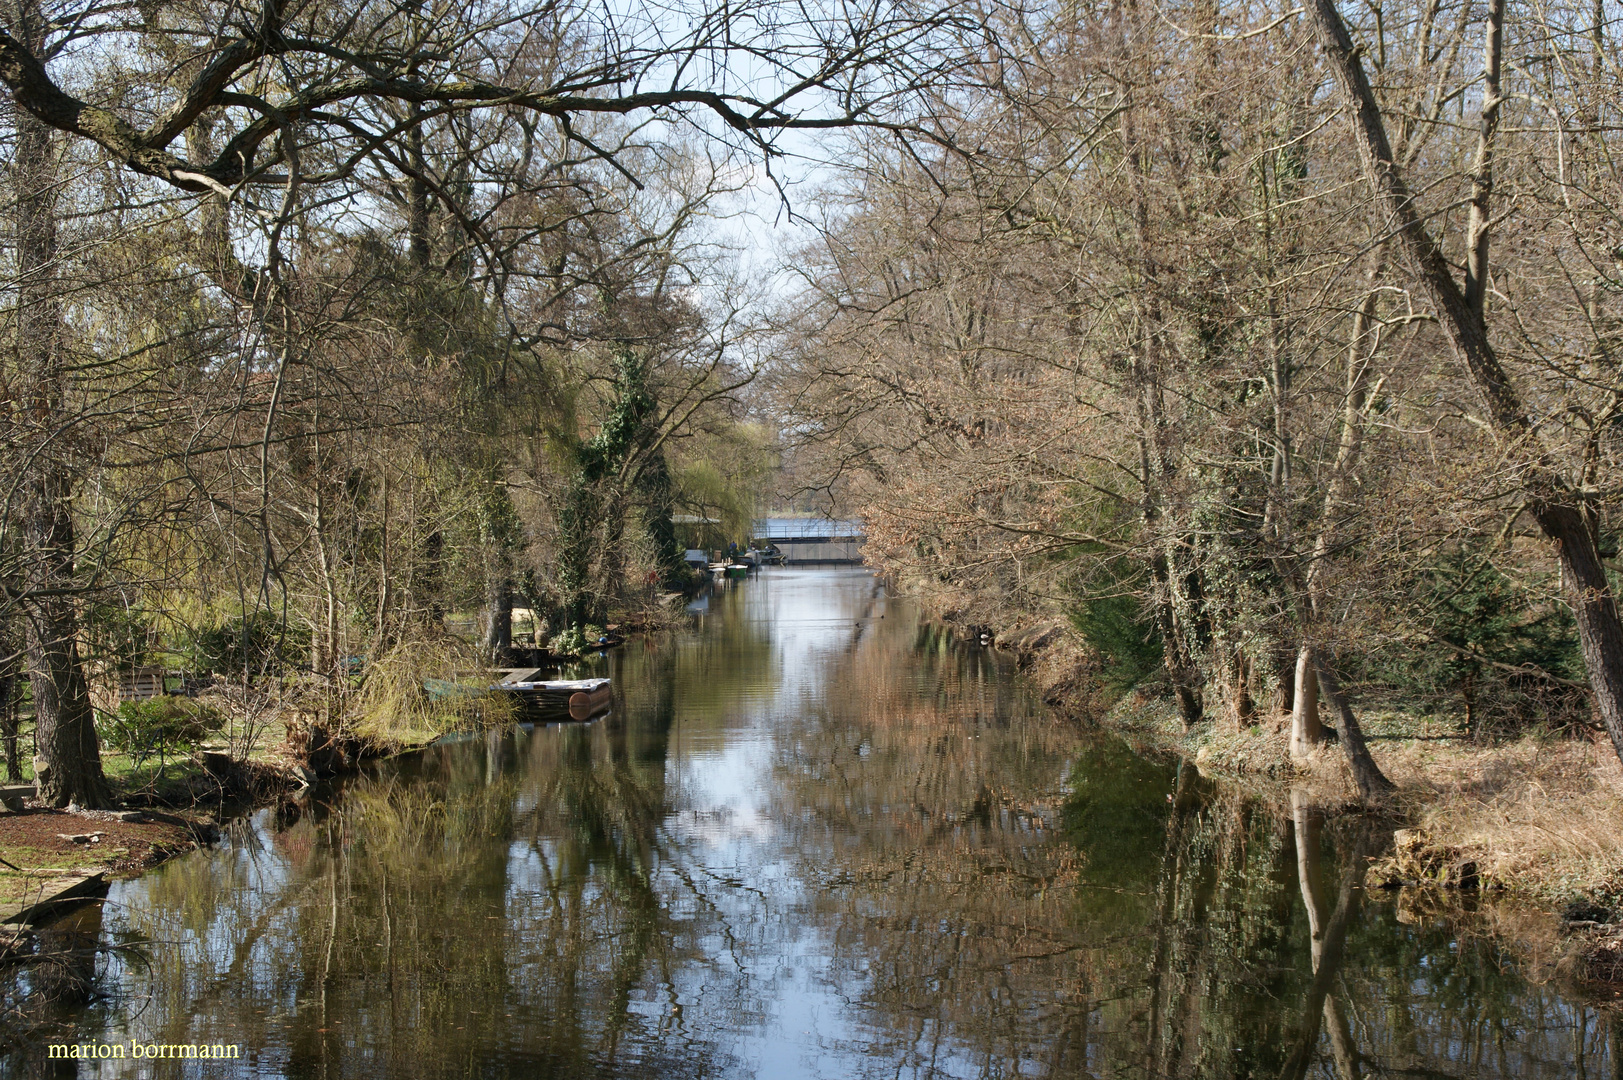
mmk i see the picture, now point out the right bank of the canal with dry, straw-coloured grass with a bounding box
[954,613,1623,1000]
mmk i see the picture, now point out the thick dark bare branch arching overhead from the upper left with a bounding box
[0,0,979,195]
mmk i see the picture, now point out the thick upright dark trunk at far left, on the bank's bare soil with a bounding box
[13,0,112,809]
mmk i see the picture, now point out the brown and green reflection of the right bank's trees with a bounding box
[766,571,1617,1080]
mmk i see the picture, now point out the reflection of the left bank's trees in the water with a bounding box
[50,665,736,1077]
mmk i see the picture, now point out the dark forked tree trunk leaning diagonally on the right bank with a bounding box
[1310,0,1623,769]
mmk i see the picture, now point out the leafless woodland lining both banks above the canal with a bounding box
[0,0,1623,806]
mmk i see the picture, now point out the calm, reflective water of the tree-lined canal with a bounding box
[0,570,1618,1080]
